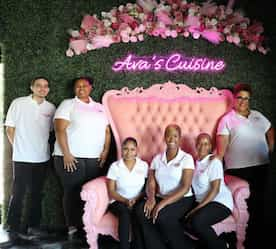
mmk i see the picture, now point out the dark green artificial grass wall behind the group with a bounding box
[0,0,276,229]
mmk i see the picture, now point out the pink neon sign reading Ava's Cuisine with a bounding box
[112,53,226,73]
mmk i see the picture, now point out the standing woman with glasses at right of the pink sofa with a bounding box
[217,83,275,248]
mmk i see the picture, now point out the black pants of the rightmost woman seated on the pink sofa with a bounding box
[187,202,231,249]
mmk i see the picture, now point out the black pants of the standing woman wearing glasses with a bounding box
[226,165,268,249]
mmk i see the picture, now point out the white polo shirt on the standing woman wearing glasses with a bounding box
[217,110,271,169]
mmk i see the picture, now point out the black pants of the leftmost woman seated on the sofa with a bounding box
[108,201,144,249]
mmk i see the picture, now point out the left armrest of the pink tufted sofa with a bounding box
[81,176,109,224]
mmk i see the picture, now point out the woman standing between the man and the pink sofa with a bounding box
[54,77,111,238]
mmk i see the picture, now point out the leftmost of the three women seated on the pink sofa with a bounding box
[107,137,148,249]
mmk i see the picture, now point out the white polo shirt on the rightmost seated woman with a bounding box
[192,155,233,210]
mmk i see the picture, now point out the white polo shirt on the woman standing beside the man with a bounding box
[53,97,108,158]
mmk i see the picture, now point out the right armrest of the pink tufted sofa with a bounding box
[224,175,250,220]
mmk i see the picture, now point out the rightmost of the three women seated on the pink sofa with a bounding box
[186,133,233,249]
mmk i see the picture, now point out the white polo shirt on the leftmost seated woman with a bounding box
[107,157,148,199]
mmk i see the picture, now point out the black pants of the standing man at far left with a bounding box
[7,162,48,231]
